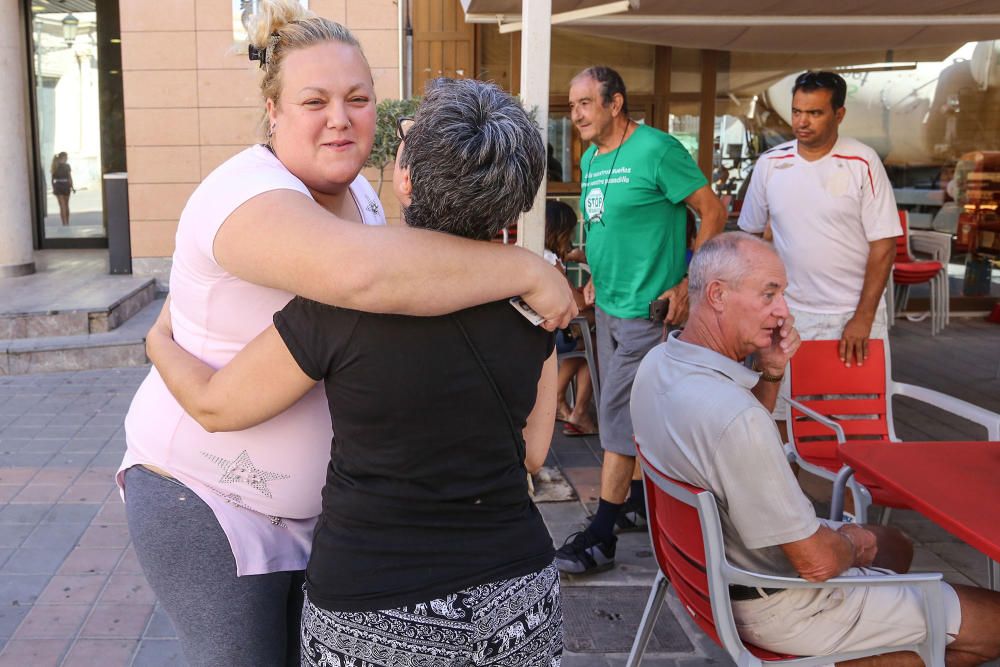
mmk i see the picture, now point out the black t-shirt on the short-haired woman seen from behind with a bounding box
[274,297,553,611]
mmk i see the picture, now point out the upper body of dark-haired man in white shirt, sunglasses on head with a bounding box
[739,72,903,376]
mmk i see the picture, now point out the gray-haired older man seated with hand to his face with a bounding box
[632,232,1000,667]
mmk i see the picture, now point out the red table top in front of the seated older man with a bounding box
[839,442,1000,561]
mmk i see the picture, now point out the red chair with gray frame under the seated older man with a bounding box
[626,447,945,667]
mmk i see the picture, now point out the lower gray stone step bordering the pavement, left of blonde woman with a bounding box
[0,291,166,375]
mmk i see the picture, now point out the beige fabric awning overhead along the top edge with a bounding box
[461,0,1000,53]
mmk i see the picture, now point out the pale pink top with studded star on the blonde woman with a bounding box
[118,146,385,576]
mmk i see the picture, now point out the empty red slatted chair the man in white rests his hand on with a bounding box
[784,339,1000,523]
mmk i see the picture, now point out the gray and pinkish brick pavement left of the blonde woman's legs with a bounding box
[0,368,183,667]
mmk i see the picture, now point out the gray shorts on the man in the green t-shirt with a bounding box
[594,308,663,456]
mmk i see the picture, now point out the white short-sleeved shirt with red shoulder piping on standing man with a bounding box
[739,137,903,313]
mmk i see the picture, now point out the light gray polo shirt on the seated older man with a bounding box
[631,332,821,576]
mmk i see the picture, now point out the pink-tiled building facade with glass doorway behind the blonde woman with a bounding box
[0,0,403,276]
